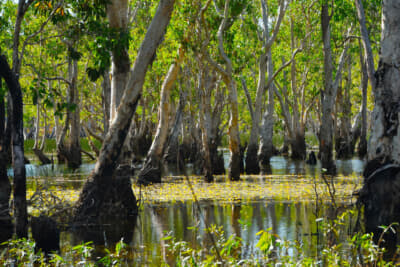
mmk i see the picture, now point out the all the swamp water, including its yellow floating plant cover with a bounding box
[10,157,364,266]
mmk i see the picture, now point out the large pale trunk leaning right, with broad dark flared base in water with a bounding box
[74,0,175,226]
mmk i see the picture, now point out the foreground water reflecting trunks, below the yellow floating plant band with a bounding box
[104,201,354,265]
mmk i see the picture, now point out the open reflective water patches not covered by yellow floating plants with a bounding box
[17,157,364,266]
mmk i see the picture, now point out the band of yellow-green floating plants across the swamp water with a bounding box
[27,175,362,219]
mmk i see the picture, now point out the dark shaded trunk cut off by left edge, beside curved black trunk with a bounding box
[0,76,13,242]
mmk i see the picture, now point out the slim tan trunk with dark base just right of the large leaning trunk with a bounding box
[138,47,184,185]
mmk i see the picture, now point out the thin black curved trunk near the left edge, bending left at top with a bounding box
[0,55,28,237]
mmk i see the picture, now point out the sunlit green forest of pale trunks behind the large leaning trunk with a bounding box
[0,0,381,173]
